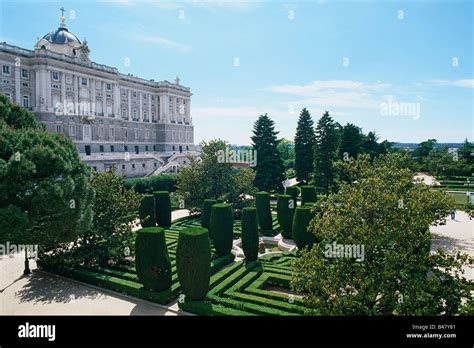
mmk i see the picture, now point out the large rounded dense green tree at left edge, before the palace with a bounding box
[0,95,94,273]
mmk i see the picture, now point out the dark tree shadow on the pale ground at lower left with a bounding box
[15,272,104,303]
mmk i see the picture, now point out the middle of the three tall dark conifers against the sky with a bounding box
[295,108,316,183]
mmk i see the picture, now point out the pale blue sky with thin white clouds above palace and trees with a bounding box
[0,0,474,144]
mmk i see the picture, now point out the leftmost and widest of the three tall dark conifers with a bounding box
[251,114,285,192]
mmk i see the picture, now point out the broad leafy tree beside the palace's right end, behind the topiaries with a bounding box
[177,139,258,212]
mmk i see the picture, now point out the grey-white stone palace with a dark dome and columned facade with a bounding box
[0,12,197,177]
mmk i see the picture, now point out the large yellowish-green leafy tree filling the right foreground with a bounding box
[292,154,472,315]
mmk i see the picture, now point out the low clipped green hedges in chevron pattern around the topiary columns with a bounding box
[41,216,304,315]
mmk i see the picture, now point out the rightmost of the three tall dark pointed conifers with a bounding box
[313,111,339,195]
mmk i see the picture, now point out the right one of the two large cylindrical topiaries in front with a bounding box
[176,227,211,300]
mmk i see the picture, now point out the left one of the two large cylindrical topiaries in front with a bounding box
[135,227,171,291]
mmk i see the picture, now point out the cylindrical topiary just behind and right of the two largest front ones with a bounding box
[210,203,234,256]
